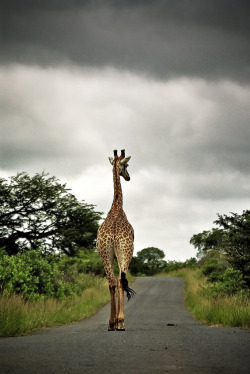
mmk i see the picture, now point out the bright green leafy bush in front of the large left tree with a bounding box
[0,250,95,301]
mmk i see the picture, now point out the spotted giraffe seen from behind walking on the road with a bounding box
[97,150,135,331]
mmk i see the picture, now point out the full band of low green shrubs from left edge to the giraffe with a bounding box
[0,250,106,301]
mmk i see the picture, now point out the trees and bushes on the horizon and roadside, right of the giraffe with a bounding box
[130,210,250,297]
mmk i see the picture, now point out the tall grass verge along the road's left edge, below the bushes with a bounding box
[0,277,110,336]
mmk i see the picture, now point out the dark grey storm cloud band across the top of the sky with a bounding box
[0,0,250,82]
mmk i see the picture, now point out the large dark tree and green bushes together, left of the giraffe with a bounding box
[0,173,104,300]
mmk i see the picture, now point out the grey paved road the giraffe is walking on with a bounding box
[0,277,250,374]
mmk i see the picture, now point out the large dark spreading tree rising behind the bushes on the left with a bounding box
[0,173,101,256]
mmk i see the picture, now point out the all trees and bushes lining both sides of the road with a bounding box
[0,173,250,300]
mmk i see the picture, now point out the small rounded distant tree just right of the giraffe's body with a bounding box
[137,247,165,275]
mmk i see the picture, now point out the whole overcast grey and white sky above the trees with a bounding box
[0,0,250,260]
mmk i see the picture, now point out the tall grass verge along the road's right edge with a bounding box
[159,268,250,328]
